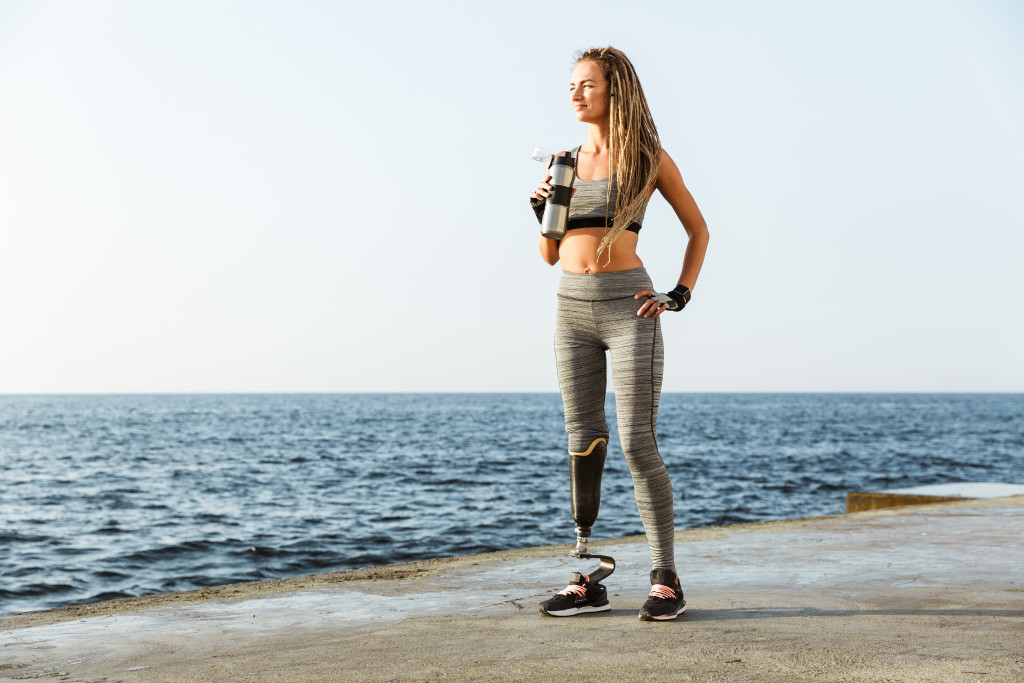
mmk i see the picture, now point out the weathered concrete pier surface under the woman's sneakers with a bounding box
[0,496,1024,683]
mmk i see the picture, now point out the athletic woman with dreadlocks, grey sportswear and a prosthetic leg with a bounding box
[530,47,708,621]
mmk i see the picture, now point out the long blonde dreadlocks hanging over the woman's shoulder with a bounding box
[575,45,662,261]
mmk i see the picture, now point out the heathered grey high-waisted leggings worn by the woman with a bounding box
[555,268,675,569]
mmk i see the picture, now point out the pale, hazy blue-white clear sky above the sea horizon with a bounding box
[0,0,1024,393]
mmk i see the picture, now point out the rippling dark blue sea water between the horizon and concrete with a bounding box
[0,394,1024,613]
